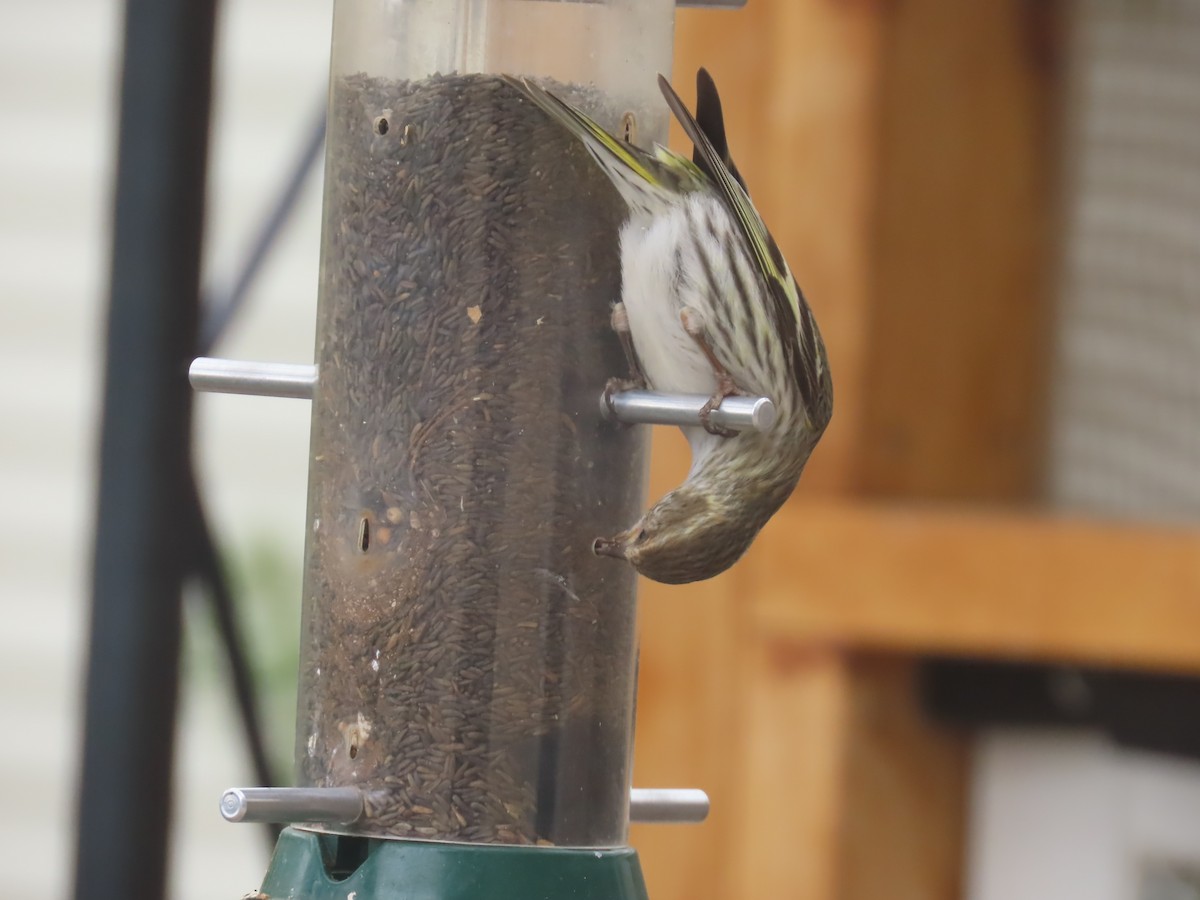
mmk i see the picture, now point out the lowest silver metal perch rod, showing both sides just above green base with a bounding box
[221,787,709,824]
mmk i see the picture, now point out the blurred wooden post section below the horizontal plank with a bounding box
[712,648,967,900]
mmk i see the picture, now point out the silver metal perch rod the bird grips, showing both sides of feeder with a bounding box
[187,356,775,432]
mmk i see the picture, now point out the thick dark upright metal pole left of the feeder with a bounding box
[74,0,215,900]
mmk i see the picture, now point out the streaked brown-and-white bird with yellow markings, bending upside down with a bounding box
[505,68,833,584]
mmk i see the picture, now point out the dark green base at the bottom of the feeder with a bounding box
[262,828,647,900]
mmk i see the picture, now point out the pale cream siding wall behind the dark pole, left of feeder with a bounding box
[0,0,330,899]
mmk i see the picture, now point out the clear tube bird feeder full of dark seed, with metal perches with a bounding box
[192,0,767,900]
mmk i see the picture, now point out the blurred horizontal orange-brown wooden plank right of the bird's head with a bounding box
[743,503,1200,671]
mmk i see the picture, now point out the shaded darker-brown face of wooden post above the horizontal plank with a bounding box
[859,0,1061,502]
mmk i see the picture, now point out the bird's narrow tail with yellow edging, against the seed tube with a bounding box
[502,76,671,211]
